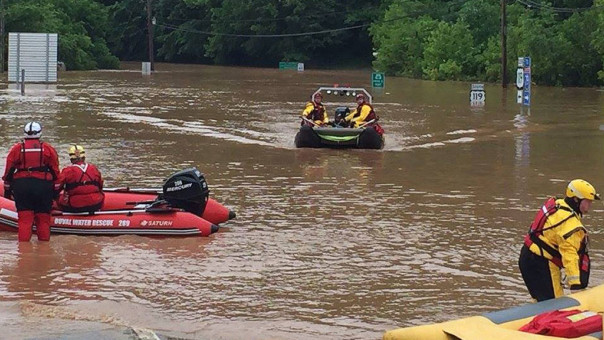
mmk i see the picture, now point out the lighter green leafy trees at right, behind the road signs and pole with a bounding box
[371,0,604,86]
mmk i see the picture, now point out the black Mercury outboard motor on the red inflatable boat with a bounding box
[162,168,210,216]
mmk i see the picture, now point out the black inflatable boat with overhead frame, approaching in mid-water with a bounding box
[294,87,384,149]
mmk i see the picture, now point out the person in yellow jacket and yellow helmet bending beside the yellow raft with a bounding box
[518,179,600,301]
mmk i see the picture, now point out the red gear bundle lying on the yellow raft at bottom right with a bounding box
[520,309,602,338]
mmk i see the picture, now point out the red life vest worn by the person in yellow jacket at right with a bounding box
[524,197,590,287]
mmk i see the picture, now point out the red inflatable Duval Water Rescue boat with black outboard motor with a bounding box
[0,168,235,236]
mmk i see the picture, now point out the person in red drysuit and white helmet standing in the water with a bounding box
[2,122,61,242]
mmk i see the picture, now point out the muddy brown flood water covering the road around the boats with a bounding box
[0,64,604,339]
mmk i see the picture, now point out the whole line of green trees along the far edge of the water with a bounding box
[1,0,604,86]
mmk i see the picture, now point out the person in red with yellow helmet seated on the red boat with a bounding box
[57,144,105,212]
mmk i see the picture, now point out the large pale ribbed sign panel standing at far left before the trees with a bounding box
[8,33,59,83]
